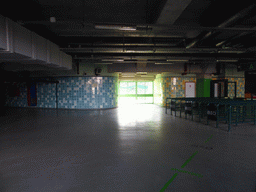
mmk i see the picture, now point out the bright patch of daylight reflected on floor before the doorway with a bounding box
[117,104,161,158]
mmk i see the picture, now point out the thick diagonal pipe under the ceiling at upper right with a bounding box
[186,4,256,49]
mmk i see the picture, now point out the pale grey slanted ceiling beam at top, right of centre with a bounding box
[156,0,192,25]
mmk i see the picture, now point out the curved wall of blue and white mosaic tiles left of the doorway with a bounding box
[4,77,118,109]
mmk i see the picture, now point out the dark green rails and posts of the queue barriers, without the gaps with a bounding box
[166,97,256,131]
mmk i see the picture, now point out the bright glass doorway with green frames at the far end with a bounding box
[118,81,154,106]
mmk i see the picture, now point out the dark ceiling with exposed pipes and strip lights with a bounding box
[0,0,256,73]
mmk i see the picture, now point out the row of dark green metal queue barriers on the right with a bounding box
[166,97,256,131]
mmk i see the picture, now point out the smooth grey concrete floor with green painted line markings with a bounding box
[0,104,256,192]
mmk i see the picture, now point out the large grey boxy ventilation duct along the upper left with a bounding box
[0,15,72,69]
